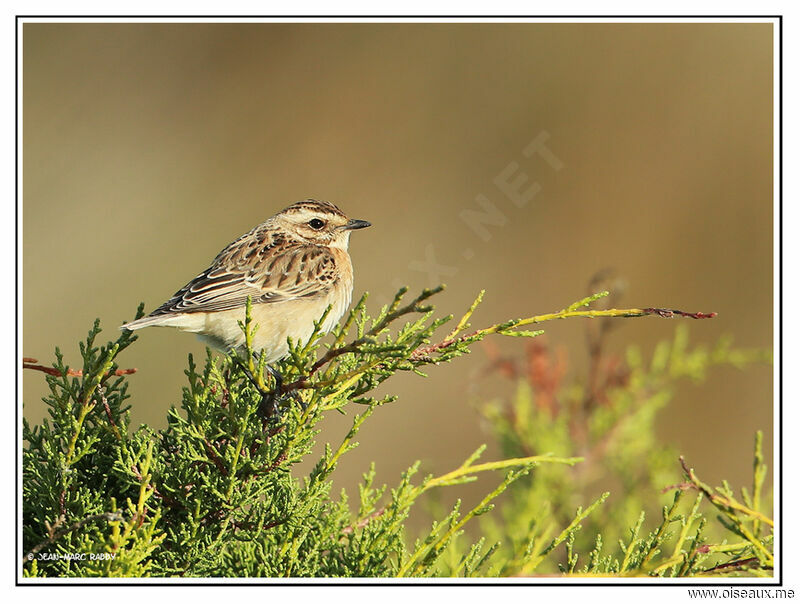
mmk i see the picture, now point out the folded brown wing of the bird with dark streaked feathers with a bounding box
[150,229,337,316]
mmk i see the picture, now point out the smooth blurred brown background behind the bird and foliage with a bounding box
[22,23,773,524]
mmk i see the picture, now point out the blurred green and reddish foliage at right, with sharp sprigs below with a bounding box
[439,326,773,577]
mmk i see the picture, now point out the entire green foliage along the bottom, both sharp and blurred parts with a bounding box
[22,288,772,577]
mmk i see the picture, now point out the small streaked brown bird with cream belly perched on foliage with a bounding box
[120,199,371,364]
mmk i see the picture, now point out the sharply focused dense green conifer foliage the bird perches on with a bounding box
[23,289,577,577]
